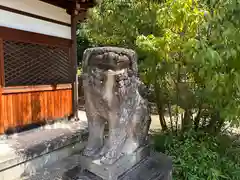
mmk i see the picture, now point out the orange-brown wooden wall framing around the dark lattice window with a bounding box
[0,27,73,134]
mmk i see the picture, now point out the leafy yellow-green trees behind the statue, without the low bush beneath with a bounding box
[80,0,240,133]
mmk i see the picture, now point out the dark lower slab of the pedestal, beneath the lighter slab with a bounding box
[62,152,172,180]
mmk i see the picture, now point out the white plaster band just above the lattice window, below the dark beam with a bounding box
[0,9,71,39]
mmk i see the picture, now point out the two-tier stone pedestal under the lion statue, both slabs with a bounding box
[76,147,172,180]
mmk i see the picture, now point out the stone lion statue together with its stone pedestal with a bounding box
[81,47,171,180]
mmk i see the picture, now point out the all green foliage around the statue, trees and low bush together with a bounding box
[79,0,240,180]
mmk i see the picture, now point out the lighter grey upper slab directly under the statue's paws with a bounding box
[81,146,150,180]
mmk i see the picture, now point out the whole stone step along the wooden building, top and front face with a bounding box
[0,121,87,180]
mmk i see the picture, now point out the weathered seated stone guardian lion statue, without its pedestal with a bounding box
[83,47,151,165]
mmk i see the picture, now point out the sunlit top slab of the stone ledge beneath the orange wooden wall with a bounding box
[0,121,88,172]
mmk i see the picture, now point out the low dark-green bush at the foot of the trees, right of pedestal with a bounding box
[154,132,240,180]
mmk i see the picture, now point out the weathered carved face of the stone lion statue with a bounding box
[86,53,135,99]
